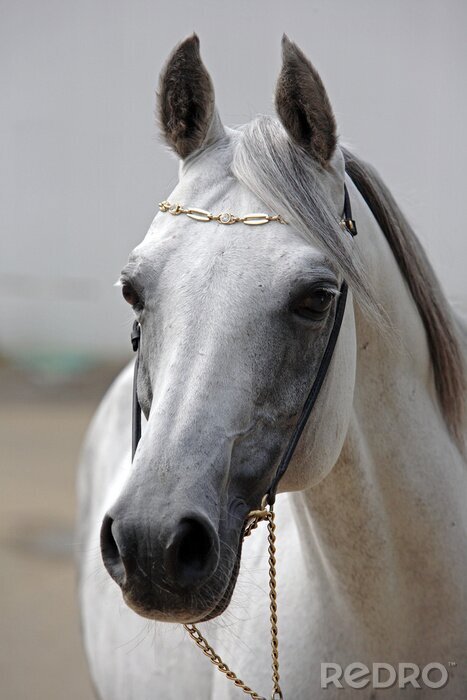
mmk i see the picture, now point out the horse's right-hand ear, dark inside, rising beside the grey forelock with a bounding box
[276,34,337,166]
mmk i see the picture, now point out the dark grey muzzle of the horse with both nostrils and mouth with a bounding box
[101,512,239,622]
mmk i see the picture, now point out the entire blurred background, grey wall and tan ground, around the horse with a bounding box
[0,0,467,700]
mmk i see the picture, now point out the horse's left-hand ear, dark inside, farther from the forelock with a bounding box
[158,34,224,158]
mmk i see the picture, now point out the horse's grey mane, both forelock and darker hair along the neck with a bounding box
[233,116,466,447]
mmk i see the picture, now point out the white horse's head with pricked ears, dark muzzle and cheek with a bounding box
[101,36,358,622]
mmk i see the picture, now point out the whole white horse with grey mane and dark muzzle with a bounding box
[79,36,467,700]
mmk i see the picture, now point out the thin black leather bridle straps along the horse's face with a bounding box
[131,185,357,505]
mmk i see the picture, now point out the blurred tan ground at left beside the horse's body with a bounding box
[0,365,126,700]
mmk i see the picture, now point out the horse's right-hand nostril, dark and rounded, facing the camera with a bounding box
[164,516,219,588]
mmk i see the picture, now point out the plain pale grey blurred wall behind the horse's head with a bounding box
[0,0,467,357]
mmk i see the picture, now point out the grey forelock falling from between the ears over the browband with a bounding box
[232,116,388,332]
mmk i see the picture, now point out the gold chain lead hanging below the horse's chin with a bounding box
[183,506,283,700]
